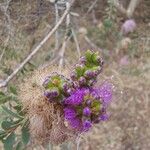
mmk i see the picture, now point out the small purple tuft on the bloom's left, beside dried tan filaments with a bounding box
[64,108,77,120]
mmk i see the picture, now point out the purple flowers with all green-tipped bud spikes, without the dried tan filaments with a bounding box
[43,51,112,132]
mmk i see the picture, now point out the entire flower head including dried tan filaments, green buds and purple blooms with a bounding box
[20,51,112,144]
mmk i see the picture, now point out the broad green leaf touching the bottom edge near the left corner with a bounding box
[3,133,16,150]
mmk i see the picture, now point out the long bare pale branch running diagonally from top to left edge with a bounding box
[0,0,74,87]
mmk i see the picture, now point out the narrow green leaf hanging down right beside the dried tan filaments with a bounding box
[22,127,30,145]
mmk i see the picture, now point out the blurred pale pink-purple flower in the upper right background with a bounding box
[121,19,136,34]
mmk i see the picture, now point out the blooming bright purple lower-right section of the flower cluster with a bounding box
[64,83,112,132]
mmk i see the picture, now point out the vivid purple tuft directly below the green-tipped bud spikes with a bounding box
[64,89,89,105]
